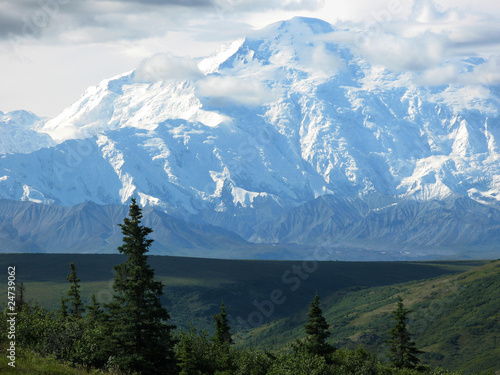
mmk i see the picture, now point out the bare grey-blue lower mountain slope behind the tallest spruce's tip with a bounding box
[0,200,262,258]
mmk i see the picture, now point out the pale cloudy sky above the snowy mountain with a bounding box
[0,0,500,117]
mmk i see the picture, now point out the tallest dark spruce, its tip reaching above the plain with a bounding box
[106,199,176,374]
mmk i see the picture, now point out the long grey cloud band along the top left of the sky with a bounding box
[0,0,323,43]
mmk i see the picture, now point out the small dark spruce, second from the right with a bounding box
[304,293,335,357]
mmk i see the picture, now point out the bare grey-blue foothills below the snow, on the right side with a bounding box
[251,195,500,258]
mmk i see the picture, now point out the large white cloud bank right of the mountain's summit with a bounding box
[312,0,500,76]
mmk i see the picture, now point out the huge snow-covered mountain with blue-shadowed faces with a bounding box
[0,18,500,258]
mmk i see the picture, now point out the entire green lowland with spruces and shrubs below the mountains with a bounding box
[0,202,500,375]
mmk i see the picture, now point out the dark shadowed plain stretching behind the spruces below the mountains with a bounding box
[0,254,480,328]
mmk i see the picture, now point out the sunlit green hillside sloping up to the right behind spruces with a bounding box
[245,261,500,374]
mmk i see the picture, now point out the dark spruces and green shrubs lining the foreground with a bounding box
[2,199,476,375]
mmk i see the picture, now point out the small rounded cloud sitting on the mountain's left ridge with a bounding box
[134,53,204,82]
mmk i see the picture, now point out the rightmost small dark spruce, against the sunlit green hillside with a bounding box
[385,297,423,369]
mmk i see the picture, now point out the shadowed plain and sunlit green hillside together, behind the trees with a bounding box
[0,254,494,370]
